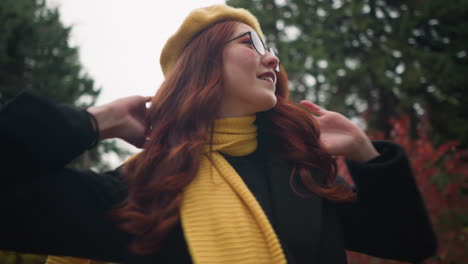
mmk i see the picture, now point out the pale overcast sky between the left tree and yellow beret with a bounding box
[48,0,224,104]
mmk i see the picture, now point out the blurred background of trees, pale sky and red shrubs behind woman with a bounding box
[0,0,468,264]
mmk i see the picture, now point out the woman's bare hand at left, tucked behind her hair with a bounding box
[88,96,151,148]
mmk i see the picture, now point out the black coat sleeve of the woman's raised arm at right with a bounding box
[338,142,437,262]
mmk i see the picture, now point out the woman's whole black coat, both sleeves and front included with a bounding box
[0,93,436,264]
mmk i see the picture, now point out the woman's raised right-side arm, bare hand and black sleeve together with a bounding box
[301,101,437,261]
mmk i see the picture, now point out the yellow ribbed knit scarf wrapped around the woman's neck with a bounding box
[181,116,286,264]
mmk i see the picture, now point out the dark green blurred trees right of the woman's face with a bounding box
[227,0,468,147]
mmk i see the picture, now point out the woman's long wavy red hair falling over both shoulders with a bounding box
[111,21,354,255]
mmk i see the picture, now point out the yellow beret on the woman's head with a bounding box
[159,5,263,75]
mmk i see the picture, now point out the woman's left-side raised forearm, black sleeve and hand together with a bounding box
[0,92,151,180]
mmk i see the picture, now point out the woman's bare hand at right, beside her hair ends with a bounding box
[301,101,379,162]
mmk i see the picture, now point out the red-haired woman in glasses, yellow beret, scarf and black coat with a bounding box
[0,5,435,263]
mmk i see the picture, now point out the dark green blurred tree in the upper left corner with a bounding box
[0,0,100,106]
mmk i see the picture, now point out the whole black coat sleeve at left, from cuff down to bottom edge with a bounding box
[0,93,132,262]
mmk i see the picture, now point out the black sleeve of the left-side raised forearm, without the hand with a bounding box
[0,92,96,181]
